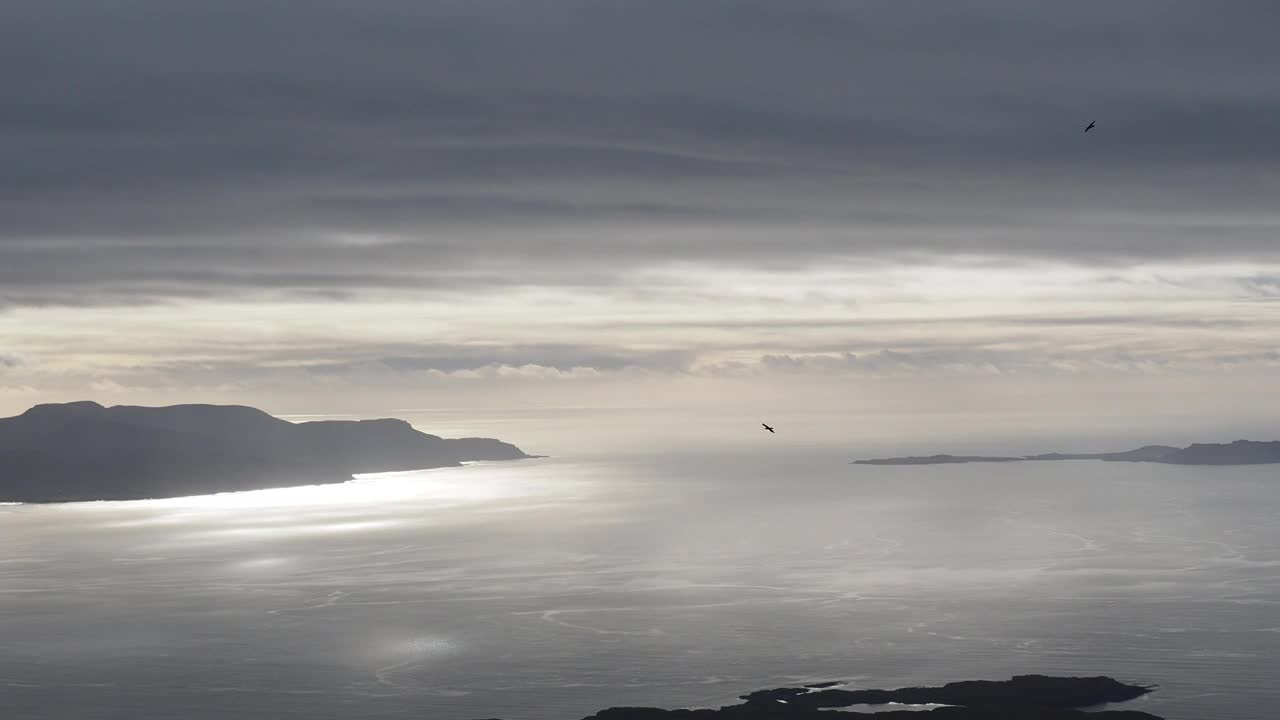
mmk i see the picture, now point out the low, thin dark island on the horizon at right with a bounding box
[854,439,1280,465]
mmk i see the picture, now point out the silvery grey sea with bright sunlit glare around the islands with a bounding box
[0,414,1280,720]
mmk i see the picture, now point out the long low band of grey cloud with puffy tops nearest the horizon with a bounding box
[104,342,1280,389]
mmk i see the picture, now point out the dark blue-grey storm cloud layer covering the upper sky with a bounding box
[0,0,1280,304]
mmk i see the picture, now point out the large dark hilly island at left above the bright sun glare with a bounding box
[0,401,532,502]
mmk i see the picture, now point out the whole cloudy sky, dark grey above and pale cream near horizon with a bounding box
[0,0,1280,439]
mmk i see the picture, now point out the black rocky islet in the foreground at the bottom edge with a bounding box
[570,675,1160,720]
